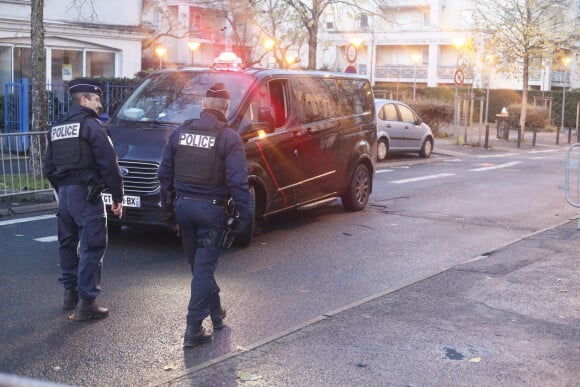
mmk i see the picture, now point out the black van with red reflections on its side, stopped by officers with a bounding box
[104,68,377,245]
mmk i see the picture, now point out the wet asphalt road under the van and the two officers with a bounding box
[0,143,577,386]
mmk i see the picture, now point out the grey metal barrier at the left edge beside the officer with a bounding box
[0,132,53,197]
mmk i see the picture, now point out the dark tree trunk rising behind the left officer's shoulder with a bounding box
[29,0,48,176]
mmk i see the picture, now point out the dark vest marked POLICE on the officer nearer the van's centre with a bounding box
[175,120,225,186]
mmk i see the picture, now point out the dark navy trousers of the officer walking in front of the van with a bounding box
[175,198,226,324]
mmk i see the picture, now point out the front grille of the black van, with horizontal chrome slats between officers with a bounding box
[119,160,160,195]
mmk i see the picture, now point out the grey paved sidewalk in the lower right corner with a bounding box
[159,220,580,386]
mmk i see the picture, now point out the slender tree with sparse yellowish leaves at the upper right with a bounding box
[474,0,575,138]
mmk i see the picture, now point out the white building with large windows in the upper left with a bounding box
[0,0,147,94]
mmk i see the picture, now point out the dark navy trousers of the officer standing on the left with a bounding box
[57,185,107,299]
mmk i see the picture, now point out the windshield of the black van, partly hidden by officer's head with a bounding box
[113,70,254,124]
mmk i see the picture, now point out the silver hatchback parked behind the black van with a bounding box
[375,98,435,161]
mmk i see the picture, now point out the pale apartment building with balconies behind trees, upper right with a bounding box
[317,0,580,90]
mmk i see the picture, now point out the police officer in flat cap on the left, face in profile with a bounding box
[44,78,123,321]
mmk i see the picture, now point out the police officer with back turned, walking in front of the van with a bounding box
[158,83,250,347]
